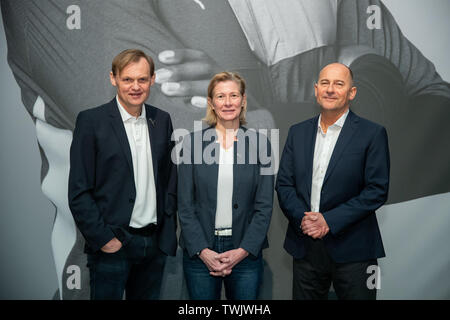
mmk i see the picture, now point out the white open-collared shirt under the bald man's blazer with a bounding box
[311,110,349,212]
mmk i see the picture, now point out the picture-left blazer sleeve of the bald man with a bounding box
[275,128,309,235]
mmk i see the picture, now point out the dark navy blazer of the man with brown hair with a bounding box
[68,98,177,255]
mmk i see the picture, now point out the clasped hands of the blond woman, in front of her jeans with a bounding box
[199,248,248,277]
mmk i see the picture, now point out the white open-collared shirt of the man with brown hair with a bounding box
[116,97,156,228]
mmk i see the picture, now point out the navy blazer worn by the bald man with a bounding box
[276,111,390,263]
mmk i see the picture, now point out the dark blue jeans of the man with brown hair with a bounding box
[87,226,166,300]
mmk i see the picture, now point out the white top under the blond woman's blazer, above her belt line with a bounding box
[215,143,234,229]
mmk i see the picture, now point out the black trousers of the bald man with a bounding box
[292,239,377,300]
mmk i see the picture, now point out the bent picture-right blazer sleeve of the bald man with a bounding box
[322,126,390,235]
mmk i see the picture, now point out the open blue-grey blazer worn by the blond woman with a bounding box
[178,127,274,257]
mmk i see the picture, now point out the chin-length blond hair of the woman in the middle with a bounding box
[203,71,247,126]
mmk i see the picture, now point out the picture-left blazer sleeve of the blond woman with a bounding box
[177,135,208,257]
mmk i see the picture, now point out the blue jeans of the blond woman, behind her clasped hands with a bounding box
[183,236,263,300]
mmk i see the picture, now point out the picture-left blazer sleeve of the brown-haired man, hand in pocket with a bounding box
[68,112,115,251]
